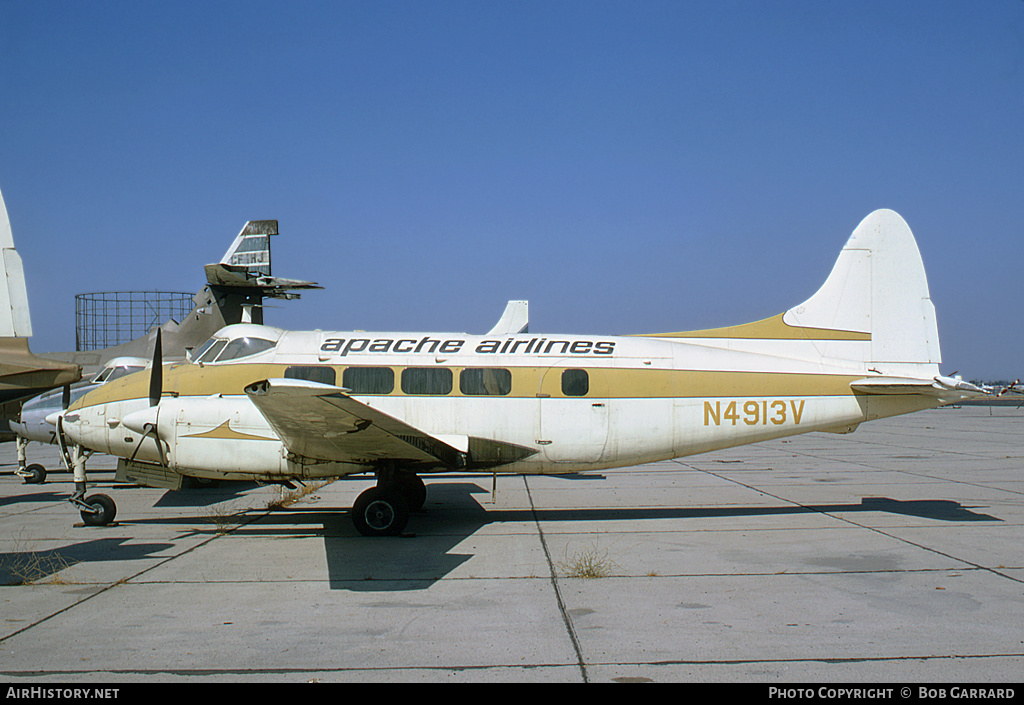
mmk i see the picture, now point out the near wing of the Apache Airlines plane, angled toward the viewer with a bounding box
[246,379,536,469]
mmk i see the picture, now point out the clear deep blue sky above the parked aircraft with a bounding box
[0,0,1024,379]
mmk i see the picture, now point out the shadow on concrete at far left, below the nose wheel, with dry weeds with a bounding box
[0,538,174,585]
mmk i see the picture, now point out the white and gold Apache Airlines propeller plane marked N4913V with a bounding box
[51,210,1007,535]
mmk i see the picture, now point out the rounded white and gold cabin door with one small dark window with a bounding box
[538,360,608,463]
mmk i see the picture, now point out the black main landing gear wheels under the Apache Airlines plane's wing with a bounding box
[352,468,427,536]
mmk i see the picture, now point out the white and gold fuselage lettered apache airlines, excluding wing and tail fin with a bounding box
[65,326,937,480]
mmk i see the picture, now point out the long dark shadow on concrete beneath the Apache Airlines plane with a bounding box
[224,483,1001,592]
